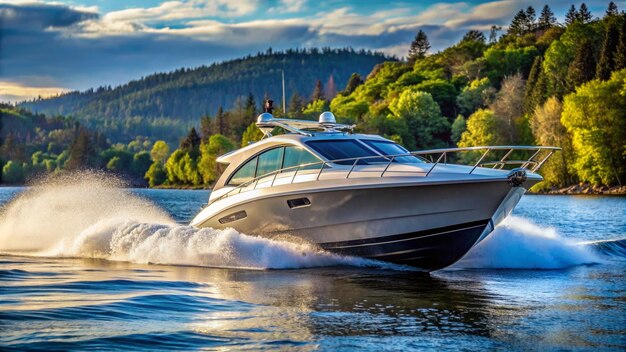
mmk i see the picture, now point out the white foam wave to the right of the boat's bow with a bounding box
[452,216,604,269]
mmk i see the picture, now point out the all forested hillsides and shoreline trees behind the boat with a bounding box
[0,2,626,194]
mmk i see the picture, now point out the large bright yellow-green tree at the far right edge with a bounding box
[561,70,626,185]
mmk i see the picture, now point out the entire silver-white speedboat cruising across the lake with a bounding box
[191,110,559,271]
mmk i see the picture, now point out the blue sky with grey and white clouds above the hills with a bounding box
[0,0,626,102]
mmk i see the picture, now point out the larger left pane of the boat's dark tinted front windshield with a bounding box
[306,139,385,165]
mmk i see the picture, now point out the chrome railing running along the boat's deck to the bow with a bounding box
[210,146,561,203]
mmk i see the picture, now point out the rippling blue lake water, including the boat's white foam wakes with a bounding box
[0,177,626,351]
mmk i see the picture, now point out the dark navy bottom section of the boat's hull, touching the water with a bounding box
[319,219,489,271]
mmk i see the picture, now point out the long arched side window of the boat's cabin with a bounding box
[228,146,321,186]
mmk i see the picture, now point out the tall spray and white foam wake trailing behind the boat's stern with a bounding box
[0,173,402,269]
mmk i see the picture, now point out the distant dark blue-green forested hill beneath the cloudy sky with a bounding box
[20,48,390,127]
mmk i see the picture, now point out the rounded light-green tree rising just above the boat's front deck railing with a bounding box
[386,88,450,149]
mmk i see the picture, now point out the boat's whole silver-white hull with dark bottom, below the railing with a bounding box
[192,175,538,271]
